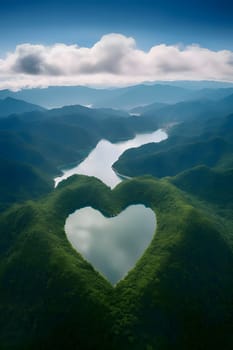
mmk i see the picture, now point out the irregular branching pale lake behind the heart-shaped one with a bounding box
[54,129,167,188]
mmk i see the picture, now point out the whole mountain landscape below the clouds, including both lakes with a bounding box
[0,82,233,350]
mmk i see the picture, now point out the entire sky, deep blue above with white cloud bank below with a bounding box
[0,0,233,89]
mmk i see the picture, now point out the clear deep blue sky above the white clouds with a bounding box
[0,0,233,53]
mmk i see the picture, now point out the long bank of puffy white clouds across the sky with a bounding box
[0,33,233,90]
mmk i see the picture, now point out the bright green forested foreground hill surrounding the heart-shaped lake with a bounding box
[0,176,233,350]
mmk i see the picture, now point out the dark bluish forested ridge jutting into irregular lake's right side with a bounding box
[113,138,233,177]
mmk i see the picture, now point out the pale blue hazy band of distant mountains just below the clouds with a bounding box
[0,81,233,109]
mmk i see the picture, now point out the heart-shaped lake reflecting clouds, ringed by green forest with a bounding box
[65,204,156,284]
